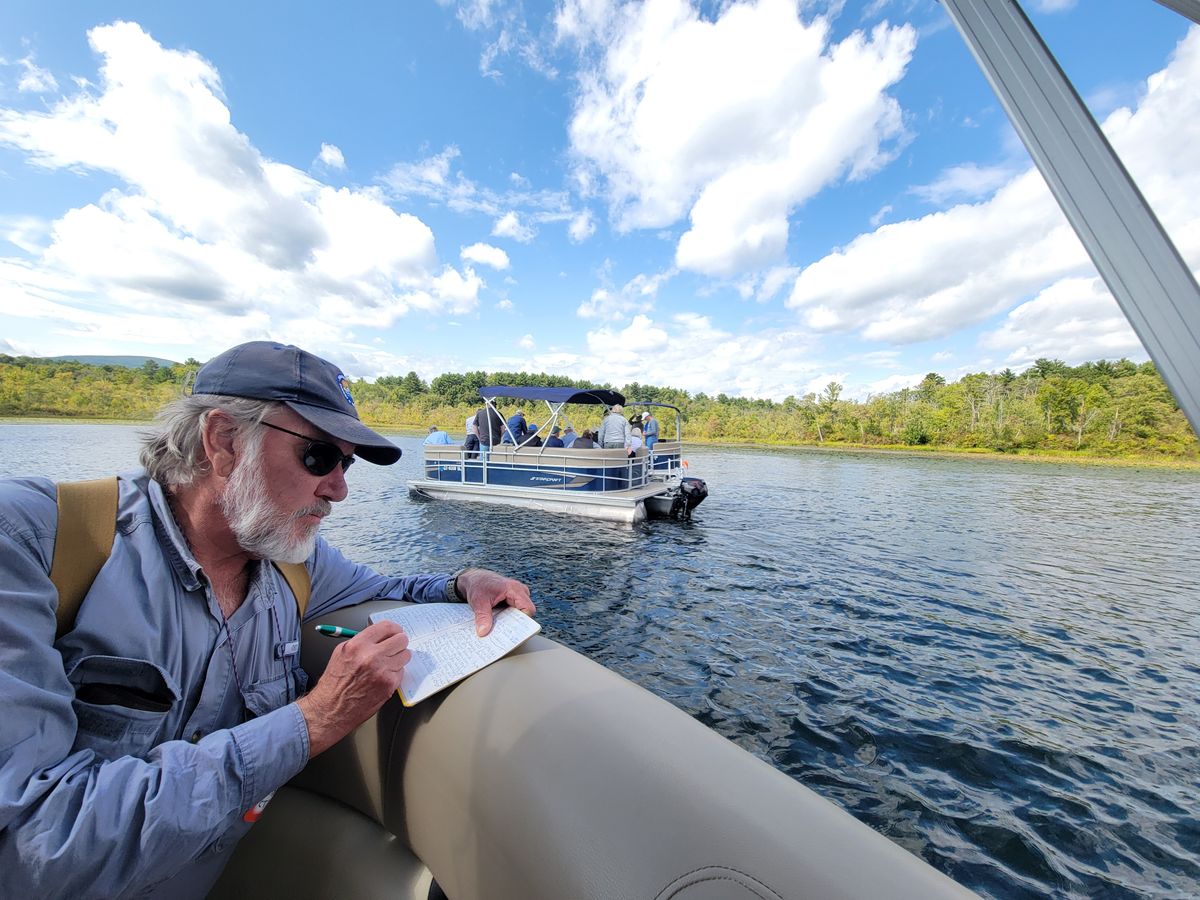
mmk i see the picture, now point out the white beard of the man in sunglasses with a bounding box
[221,438,334,563]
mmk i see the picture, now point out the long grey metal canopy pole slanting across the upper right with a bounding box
[942,0,1200,433]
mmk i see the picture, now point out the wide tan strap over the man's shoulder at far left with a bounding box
[50,476,116,637]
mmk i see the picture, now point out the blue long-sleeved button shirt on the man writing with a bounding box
[0,473,449,899]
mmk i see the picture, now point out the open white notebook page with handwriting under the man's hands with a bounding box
[371,604,541,707]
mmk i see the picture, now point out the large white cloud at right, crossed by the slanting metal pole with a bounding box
[787,28,1200,365]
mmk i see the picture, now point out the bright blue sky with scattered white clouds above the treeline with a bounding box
[0,0,1200,400]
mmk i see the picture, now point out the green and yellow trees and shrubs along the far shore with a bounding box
[0,354,1200,468]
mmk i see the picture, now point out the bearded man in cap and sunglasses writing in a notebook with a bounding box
[0,341,534,898]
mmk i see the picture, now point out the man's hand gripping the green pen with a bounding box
[296,624,410,756]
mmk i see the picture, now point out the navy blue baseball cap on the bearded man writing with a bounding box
[192,341,401,466]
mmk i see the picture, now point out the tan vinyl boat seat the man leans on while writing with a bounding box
[214,601,973,900]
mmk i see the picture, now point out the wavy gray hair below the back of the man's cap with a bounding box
[139,394,283,487]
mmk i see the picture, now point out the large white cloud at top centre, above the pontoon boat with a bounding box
[558,0,916,276]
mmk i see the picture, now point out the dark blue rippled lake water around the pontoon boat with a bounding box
[0,424,1200,898]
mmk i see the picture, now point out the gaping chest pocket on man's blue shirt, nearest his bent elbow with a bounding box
[67,655,180,760]
